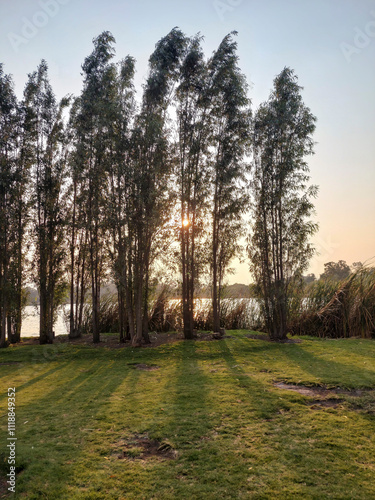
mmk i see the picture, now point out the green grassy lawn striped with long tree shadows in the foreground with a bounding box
[0,331,375,500]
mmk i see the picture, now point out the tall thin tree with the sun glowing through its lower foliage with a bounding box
[176,36,210,339]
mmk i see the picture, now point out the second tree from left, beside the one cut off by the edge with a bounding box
[23,61,68,344]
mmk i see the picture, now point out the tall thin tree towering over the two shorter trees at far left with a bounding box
[76,31,117,342]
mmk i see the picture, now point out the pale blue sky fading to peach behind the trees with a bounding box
[0,0,375,283]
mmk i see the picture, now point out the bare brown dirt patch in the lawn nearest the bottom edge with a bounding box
[118,434,177,460]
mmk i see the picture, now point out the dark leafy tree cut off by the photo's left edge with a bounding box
[0,64,27,347]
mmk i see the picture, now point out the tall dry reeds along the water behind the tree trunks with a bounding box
[67,267,375,338]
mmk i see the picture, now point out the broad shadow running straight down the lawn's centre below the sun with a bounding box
[149,340,250,499]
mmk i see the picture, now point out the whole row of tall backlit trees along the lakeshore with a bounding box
[0,28,315,346]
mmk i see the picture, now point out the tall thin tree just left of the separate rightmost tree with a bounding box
[207,32,251,332]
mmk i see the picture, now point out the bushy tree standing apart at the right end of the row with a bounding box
[248,68,317,340]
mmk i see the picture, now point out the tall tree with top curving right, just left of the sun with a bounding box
[131,28,186,346]
